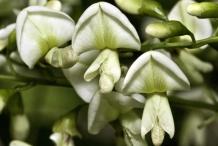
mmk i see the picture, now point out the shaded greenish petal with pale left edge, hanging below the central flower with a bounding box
[88,91,119,134]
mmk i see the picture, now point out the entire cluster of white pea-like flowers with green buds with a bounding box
[0,0,218,146]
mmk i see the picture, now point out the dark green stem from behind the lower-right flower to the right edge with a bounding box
[168,97,218,111]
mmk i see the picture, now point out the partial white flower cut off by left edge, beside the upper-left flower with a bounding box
[0,24,15,51]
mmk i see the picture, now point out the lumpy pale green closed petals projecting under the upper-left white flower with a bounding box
[45,46,79,69]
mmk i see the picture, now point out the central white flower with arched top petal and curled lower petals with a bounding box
[72,2,141,93]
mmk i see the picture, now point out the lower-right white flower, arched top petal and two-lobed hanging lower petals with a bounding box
[122,51,190,145]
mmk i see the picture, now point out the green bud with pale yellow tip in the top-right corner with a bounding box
[187,2,218,18]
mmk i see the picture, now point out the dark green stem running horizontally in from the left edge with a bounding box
[0,75,72,87]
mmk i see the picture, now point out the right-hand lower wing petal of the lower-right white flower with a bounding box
[158,93,175,138]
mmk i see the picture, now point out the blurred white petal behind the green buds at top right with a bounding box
[168,0,212,40]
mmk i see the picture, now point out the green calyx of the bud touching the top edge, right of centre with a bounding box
[139,0,168,21]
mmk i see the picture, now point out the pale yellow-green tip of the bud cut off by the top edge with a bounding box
[115,0,143,14]
